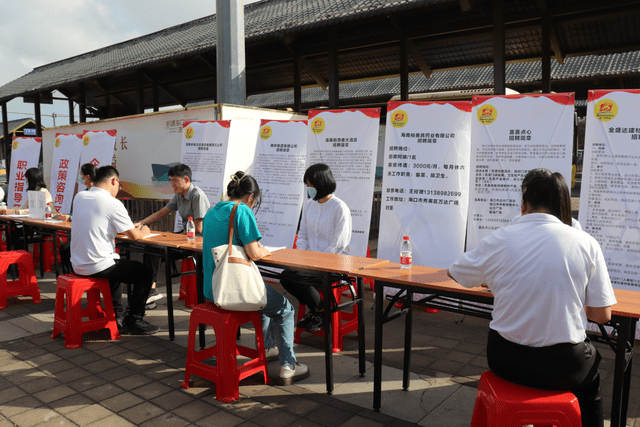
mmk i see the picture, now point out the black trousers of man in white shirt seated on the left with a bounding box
[89,259,153,320]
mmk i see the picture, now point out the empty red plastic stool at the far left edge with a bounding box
[0,251,41,309]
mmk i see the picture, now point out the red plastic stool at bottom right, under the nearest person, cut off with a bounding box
[471,371,582,427]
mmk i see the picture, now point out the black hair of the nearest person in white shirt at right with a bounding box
[522,172,571,225]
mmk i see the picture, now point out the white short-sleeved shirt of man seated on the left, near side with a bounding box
[71,187,134,276]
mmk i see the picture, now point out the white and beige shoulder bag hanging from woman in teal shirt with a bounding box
[211,203,267,311]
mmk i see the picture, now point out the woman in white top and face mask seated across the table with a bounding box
[280,163,351,332]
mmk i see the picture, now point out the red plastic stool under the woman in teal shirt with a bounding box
[182,302,271,402]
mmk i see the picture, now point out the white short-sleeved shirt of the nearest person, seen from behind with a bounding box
[449,213,616,347]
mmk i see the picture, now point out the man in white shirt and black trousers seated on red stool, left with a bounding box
[71,166,160,335]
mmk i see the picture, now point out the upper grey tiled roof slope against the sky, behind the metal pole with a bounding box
[0,0,450,101]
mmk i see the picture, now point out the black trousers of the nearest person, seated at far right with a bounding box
[487,330,604,427]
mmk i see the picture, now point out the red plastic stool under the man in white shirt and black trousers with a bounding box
[51,274,120,348]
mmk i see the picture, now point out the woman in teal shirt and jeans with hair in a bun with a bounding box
[202,171,309,385]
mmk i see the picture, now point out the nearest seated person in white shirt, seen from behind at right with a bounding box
[449,173,616,427]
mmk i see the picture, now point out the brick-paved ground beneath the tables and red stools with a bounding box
[0,260,640,427]
